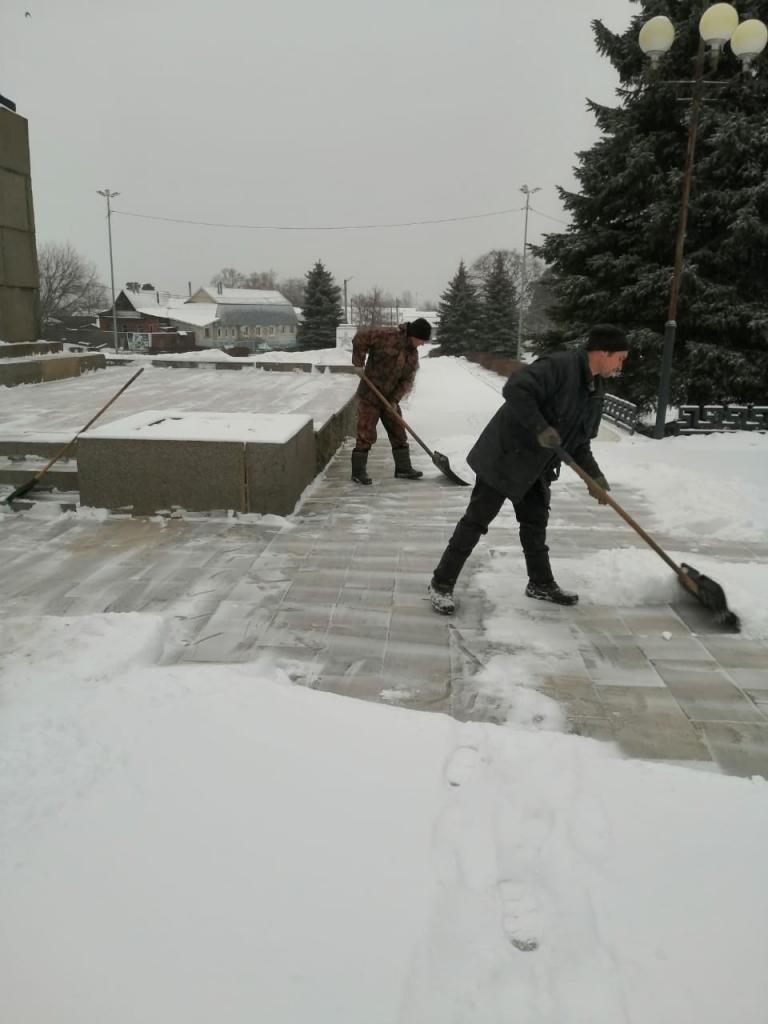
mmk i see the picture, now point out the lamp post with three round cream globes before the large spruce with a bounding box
[638,3,768,438]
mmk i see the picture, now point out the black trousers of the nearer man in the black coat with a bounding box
[434,477,553,588]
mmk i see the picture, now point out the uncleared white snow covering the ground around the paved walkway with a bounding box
[0,353,768,1024]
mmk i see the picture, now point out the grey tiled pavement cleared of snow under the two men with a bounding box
[0,444,768,775]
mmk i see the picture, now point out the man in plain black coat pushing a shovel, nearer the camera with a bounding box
[429,324,629,615]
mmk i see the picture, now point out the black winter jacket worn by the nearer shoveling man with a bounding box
[467,348,605,501]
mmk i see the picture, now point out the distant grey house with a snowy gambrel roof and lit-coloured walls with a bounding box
[189,285,299,352]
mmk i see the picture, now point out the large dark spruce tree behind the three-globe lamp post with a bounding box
[536,0,768,404]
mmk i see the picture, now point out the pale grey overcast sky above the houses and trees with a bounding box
[0,0,638,303]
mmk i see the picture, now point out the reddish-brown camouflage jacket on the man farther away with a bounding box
[352,324,419,406]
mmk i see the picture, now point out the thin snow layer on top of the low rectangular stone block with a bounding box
[83,409,312,444]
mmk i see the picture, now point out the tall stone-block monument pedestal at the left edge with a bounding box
[0,108,41,342]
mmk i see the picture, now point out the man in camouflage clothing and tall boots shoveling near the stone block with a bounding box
[352,316,432,483]
